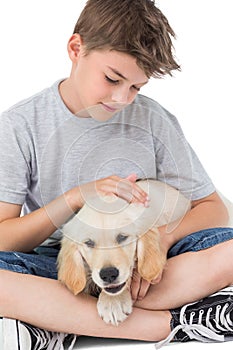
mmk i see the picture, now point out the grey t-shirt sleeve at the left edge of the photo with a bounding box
[0,112,30,204]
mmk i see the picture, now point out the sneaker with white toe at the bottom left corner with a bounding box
[0,317,77,350]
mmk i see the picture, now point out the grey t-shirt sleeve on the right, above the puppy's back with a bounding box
[152,106,215,200]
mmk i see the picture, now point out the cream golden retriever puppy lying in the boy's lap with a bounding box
[58,180,190,325]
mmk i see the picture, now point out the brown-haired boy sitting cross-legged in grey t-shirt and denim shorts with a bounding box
[0,0,233,349]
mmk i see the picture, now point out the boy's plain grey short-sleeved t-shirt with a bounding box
[0,80,215,244]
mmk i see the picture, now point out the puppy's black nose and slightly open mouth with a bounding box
[99,266,125,294]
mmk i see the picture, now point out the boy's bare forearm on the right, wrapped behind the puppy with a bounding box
[159,192,229,250]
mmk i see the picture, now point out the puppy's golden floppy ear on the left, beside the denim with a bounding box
[58,238,86,295]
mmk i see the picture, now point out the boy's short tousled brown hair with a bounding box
[74,0,180,77]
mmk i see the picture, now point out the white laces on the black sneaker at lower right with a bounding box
[155,303,233,349]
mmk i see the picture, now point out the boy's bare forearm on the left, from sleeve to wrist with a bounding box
[0,189,81,252]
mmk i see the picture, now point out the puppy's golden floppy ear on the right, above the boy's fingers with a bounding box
[137,229,166,282]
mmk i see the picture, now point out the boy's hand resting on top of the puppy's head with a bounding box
[79,174,149,206]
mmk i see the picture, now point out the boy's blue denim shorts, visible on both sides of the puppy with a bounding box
[0,228,233,279]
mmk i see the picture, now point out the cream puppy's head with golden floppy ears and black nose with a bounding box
[58,194,165,295]
